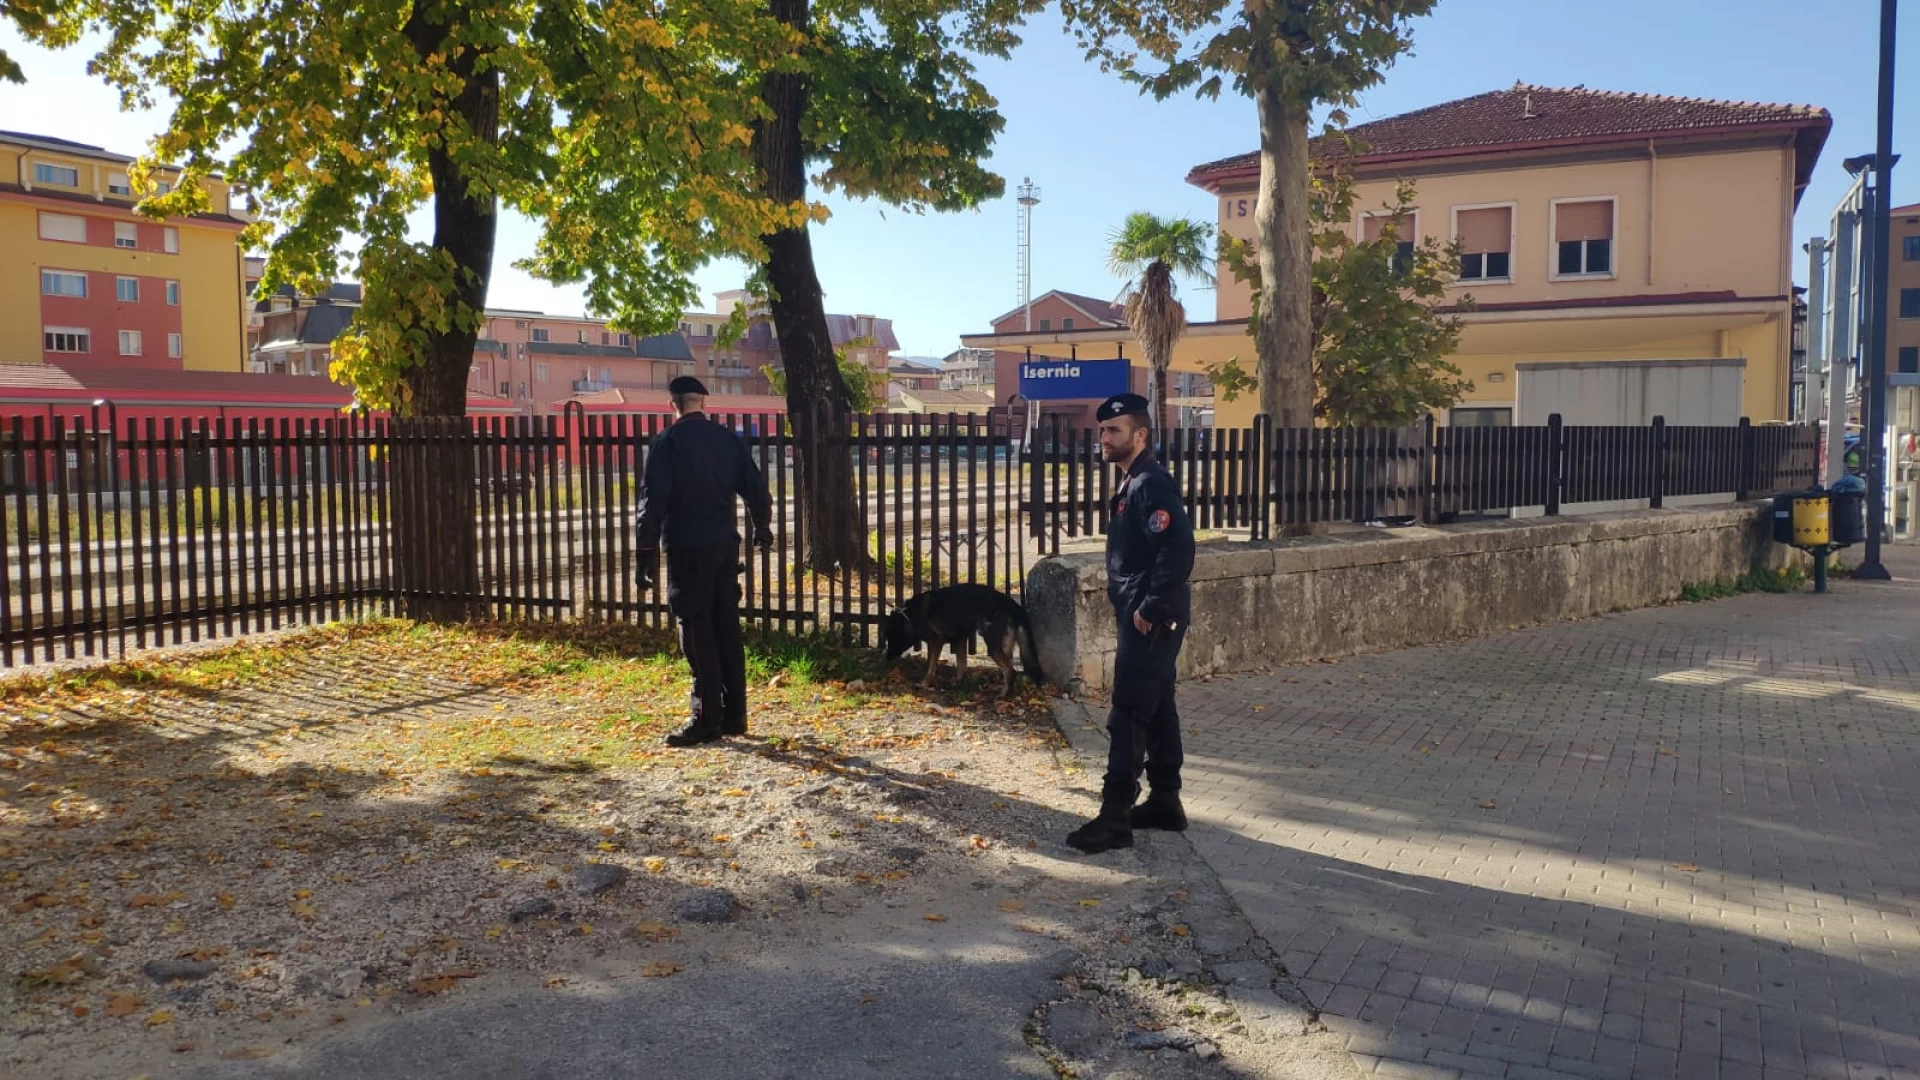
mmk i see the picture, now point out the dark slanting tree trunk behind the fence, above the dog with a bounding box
[753,0,868,573]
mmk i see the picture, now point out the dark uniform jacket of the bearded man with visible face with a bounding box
[1106,452,1194,625]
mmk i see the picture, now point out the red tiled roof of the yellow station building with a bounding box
[1187,83,1834,194]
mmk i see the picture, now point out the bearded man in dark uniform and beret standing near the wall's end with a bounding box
[1068,394,1194,853]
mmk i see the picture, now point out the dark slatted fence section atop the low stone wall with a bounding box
[1021,415,1818,553]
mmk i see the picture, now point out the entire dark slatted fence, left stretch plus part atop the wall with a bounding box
[0,407,1816,665]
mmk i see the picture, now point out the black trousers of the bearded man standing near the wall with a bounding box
[1100,615,1187,811]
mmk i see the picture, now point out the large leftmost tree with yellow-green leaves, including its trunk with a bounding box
[6,0,808,619]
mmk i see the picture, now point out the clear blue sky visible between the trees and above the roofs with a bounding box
[0,0,1920,356]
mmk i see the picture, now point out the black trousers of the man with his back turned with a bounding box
[666,544,747,730]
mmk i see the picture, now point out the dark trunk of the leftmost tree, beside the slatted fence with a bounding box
[392,2,499,623]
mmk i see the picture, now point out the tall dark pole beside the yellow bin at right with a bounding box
[1853,0,1899,580]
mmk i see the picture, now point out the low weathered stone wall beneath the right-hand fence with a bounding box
[1023,505,1799,690]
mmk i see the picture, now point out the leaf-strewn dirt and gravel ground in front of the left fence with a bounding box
[0,623,1351,1078]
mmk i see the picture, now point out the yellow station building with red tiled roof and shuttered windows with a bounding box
[962,85,1832,427]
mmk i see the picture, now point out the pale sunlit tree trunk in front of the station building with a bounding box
[1254,86,1313,427]
